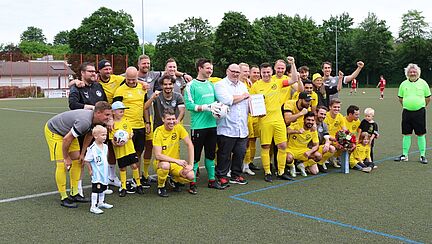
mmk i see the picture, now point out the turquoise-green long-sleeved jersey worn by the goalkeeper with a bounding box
[184,79,216,130]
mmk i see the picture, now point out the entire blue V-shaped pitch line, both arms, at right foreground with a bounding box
[230,151,432,244]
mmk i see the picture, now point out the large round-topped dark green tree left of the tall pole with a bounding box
[69,7,139,64]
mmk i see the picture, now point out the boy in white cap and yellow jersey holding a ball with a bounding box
[109,101,144,197]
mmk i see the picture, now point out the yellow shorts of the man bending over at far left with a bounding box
[44,124,80,161]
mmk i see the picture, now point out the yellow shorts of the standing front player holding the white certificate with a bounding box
[259,120,287,145]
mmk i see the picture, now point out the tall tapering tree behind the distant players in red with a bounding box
[354,13,393,84]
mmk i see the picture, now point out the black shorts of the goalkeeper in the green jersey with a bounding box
[191,127,217,162]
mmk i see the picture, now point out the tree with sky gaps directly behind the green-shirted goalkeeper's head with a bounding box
[154,17,213,74]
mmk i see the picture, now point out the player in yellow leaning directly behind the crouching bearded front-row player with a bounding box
[284,92,312,126]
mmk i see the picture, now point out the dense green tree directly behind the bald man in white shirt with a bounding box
[214,12,264,76]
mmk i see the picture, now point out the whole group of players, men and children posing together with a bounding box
[45,55,430,214]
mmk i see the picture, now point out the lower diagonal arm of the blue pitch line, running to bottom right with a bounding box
[230,196,422,244]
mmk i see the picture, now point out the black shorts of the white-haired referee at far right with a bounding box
[402,108,426,135]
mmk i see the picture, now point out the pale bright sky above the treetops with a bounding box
[0,0,432,44]
